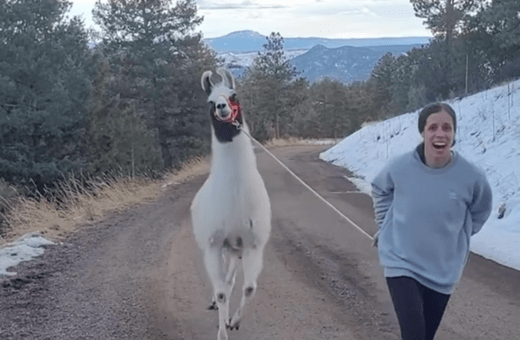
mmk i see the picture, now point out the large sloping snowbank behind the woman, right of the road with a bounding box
[320,80,520,270]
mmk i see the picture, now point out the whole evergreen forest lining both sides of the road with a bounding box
[0,0,520,197]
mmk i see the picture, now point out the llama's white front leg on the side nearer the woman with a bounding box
[229,247,263,329]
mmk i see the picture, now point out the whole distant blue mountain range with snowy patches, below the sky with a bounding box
[205,31,430,83]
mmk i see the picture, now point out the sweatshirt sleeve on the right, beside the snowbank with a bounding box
[469,172,493,236]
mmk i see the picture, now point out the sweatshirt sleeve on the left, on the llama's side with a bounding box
[372,167,394,229]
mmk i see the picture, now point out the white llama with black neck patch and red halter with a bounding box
[191,68,271,340]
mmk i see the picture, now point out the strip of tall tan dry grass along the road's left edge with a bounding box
[0,158,208,244]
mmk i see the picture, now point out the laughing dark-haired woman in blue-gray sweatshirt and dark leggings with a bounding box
[372,103,492,340]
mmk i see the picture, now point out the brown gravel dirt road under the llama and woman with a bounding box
[0,146,520,340]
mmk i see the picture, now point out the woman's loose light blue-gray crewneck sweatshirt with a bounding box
[372,149,492,294]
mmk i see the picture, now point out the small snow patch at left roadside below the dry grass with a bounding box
[0,233,54,279]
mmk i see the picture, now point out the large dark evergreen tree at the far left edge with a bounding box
[0,0,92,188]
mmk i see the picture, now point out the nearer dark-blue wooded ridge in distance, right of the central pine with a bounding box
[290,45,421,84]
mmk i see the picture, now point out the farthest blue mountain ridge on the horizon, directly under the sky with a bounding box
[204,31,430,54]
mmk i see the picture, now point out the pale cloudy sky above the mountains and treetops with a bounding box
[71,0,431,38]
